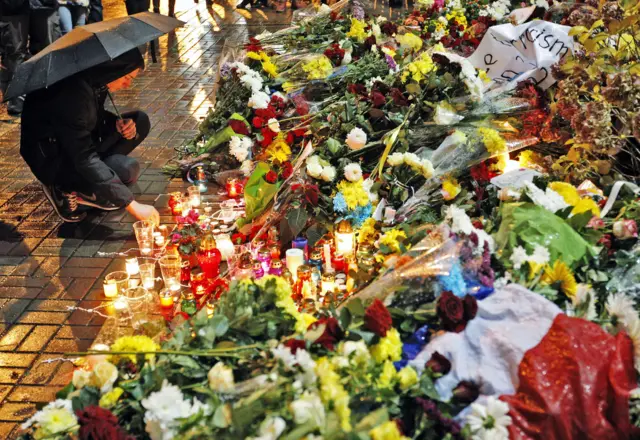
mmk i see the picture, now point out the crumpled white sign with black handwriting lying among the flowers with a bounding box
[468,20,573,89]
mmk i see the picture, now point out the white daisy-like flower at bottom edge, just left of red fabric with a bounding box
[466,396,511,440]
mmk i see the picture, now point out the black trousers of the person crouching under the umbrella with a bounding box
[56,111,151,193]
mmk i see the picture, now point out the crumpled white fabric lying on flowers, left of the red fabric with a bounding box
[410,284,561,399]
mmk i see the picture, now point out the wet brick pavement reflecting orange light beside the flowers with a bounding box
[0,0,404,439]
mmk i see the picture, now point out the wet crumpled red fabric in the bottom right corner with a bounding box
[500,314,636,440]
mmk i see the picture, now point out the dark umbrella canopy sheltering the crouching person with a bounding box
[4,12,184,101]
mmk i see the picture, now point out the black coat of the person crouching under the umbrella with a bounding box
[20,49,143,207]
